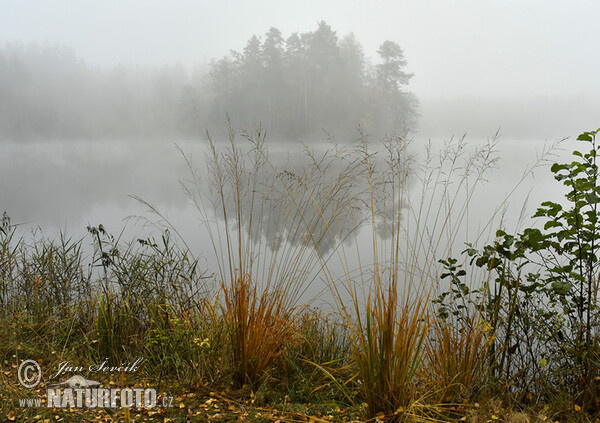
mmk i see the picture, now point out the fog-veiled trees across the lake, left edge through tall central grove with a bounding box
[0,22,418,140]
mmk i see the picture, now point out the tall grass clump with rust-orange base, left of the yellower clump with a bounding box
[180,124,364,386]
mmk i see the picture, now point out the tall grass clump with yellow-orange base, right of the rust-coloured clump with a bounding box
[296,133,502,418]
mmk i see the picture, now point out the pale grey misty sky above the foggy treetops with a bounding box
[0,0,600,98]
